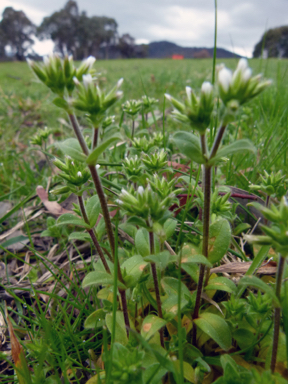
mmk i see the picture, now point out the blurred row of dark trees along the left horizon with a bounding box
[0,0,147,61]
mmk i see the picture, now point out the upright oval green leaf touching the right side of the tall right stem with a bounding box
[208,219,231,264]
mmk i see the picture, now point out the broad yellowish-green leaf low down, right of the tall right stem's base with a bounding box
[194,312,232,351]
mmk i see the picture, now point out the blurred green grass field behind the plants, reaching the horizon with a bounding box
[0,59,288,200]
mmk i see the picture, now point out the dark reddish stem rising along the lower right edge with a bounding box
[270,255,285,373]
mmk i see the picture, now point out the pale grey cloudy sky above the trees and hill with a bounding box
[0,0,288,57]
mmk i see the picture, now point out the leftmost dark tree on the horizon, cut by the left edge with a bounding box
[0,7,36,60]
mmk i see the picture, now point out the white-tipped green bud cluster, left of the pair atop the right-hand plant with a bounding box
[165,81,214,133]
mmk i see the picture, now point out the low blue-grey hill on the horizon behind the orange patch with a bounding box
[147,41,241,59]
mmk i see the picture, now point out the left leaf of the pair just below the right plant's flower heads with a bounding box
[172,131,205,164]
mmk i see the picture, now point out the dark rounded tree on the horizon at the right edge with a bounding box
[253,26,288,57]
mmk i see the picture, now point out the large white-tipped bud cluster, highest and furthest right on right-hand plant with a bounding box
[218,59,271,108]
